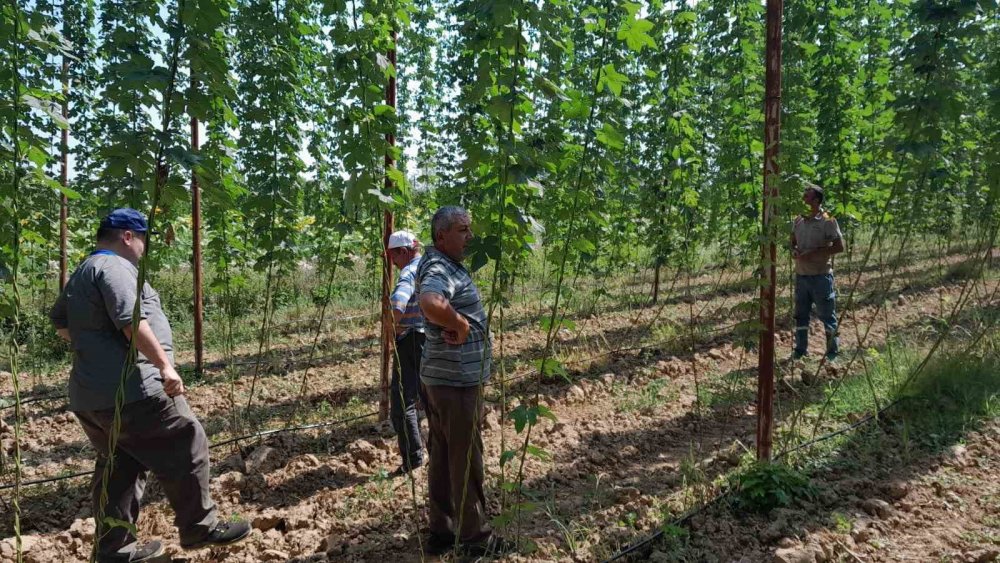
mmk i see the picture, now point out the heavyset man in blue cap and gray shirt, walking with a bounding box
[49,208,250,563]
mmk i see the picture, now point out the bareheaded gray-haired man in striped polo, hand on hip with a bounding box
[417,206,510,555]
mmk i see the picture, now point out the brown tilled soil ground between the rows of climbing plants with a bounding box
[0,252,1000,562]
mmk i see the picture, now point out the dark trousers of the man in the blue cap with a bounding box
[74,394,216,561]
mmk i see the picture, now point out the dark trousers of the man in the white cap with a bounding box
[389,331,427,468]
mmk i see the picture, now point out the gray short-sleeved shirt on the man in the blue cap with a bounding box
[49,254,174,411]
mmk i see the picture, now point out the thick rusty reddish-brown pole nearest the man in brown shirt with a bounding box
[757,0,782,461]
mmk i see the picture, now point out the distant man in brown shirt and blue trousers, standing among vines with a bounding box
[792,183,844,360]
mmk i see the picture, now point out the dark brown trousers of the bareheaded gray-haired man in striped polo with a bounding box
[423,385,490,543]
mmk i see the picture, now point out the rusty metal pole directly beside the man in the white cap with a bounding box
[378,30,396,420]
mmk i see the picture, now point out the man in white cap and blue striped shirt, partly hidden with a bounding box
[387,231,424,475]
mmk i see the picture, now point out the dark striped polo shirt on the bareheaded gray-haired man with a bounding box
[416,247,492,387]
